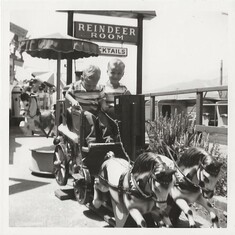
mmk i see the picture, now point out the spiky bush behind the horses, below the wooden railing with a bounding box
[146,113,227,196]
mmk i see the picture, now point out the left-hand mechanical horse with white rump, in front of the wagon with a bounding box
[93,152,175,227]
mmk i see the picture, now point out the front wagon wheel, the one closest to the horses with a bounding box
[73,167,91,205]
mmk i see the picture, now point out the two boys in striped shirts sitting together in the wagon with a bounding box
[65,59,130,145]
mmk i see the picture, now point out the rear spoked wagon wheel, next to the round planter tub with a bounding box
[53,145,69,186]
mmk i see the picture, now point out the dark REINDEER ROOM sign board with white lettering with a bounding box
[74,21,138,44]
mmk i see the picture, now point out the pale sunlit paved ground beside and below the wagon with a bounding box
[9,126,210,228]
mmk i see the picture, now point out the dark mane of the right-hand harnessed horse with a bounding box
[177,147,222,176]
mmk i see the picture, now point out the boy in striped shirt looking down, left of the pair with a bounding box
[65,65,113,145]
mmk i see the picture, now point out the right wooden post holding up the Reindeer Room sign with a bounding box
[136,15,143,94]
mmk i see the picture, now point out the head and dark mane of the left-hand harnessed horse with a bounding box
[132,152,176,210]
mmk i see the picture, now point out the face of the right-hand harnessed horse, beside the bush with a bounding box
[197,154,222,198]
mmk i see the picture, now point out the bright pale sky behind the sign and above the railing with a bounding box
[3,0,231,93]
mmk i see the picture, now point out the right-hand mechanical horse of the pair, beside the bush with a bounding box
[168,147,222,228]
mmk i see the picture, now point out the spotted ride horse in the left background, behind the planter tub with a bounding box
[20,93,55,137]
